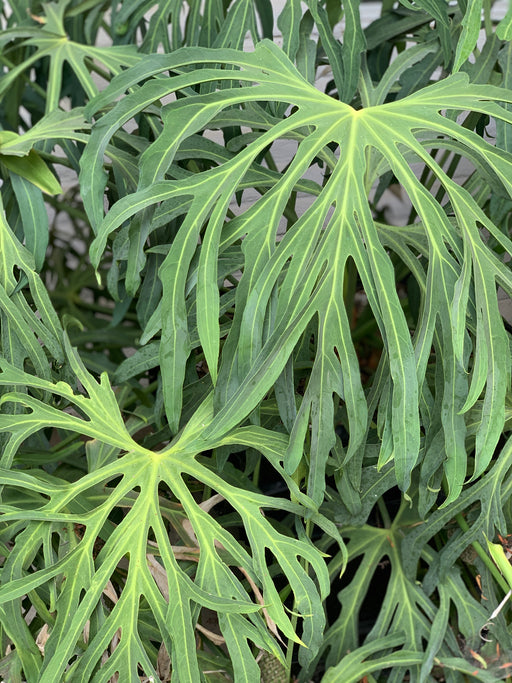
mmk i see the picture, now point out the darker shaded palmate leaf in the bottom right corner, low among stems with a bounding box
[323,532,488,683]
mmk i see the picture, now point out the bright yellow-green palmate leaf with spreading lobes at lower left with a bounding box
[0,360,337,681]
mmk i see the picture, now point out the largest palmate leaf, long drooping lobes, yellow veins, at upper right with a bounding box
[82,41,512,503]
